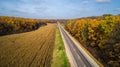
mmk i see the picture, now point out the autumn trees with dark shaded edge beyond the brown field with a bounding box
[0,16,48,36]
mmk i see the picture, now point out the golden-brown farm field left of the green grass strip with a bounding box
[0,24,56,67]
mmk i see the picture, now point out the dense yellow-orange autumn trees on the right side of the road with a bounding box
[65,14,120,67]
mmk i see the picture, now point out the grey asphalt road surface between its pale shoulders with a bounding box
[58,24,92,67]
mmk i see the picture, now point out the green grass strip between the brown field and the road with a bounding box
[51,28,70,67]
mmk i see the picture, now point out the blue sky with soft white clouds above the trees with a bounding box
[0,0,120,19]
